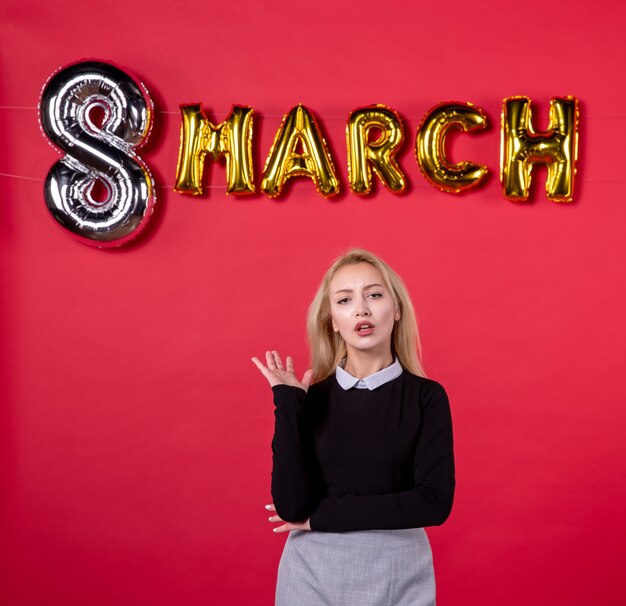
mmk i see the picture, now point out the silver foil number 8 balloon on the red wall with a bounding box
[40,61,155,247]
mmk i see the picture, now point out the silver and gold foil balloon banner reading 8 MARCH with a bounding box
[39,61,579,247]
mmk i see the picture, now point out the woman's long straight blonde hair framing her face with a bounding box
[306,248,426,382]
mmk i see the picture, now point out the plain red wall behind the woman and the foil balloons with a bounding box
[0,0,626,606]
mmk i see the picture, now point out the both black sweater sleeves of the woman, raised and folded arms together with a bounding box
[272,381,455,532]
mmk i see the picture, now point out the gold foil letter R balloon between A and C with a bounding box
[346,105,406,194]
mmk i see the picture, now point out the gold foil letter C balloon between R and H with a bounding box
[415,102,487,194]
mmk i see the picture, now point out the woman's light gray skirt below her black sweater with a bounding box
[276,528,435,606]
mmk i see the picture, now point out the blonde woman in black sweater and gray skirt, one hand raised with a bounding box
[252,249,455,606]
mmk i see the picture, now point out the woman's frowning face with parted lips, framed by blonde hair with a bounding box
[329,263,400,355]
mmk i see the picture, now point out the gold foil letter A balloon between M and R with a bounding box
[261,105,339,198]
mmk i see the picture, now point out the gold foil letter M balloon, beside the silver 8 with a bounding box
[174,105,254,195]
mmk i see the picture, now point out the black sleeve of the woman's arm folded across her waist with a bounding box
[310,381,455,532]
